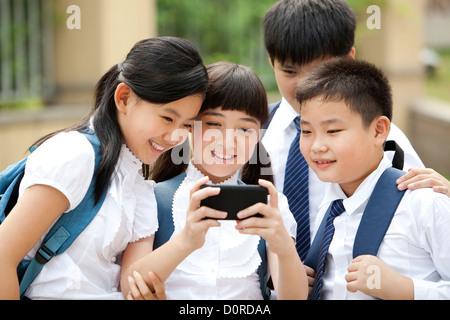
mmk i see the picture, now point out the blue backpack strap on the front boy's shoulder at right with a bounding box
[353,167,406,258]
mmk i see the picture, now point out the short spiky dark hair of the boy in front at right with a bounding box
[296,58,392,127]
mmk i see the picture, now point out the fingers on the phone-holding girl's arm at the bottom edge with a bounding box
[127,271,167,300]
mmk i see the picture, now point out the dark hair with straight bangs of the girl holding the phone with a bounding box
[151,62,273,184]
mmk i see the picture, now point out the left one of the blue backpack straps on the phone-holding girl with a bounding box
[153,172,186,250]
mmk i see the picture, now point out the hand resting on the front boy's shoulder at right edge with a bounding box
[397,168,450,197]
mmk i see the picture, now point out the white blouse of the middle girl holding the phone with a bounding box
[165,163,296,300]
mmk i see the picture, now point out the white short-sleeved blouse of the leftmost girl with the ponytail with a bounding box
[19,131,158,300]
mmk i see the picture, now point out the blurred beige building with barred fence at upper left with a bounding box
[0,0,156,170]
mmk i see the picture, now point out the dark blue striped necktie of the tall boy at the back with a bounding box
[283,117,311,261]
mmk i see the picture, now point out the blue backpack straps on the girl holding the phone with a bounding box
[153,172,271,300]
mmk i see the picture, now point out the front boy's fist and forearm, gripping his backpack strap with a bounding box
[345,255,414,300]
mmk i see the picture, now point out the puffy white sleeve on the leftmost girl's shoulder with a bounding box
[19,131,95,212]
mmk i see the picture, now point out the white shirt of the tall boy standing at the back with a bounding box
[262,98,424,239]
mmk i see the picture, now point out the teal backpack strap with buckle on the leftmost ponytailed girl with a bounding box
[18,131,106,297]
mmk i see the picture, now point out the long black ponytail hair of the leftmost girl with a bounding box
[34,37,208,201]
